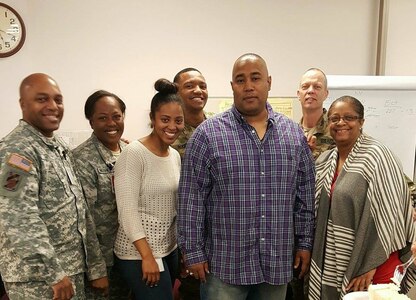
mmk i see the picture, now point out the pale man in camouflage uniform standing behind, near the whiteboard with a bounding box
[286,68,335,300]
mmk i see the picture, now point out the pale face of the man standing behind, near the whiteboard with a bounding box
[297,69,328,111]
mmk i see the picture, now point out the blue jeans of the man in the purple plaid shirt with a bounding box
[201,274,287,300]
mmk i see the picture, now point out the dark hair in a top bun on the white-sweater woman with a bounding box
[150,78,183,118]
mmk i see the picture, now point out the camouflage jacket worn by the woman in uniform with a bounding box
[73,133,126,267]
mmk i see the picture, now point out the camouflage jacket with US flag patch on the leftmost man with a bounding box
[0,120,107,285]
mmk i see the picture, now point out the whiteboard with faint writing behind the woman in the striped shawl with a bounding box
[324,75,416,179]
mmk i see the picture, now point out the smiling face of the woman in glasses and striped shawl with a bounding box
[328,101,364,149]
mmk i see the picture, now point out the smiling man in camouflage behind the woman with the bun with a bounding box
[172,68,208,300]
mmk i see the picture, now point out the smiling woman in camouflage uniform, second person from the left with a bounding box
[73,90,129,300]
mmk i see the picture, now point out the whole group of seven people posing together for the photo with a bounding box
[0,53,416,300]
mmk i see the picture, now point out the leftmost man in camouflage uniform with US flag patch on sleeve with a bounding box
[0,73,108,300]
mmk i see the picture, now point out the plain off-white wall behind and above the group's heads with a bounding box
[0,0,416,139]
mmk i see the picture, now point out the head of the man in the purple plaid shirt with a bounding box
[231,55,272,116]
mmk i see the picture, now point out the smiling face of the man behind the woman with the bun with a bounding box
[177,71,208,112]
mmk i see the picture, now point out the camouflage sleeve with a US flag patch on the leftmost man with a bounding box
[0,154,66,285]
